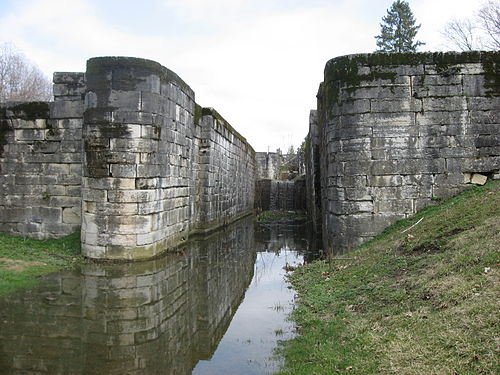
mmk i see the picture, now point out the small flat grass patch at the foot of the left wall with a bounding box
[0,233,83,295]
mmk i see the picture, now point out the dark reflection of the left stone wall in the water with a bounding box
[0,219,256,375]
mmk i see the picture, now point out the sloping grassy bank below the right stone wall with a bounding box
[281,182,500,375]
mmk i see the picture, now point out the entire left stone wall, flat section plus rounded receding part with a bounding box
[0,57,255,260]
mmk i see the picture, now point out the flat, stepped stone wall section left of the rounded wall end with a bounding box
[0,73,85,239]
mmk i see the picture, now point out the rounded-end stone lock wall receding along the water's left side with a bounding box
[82,58,255,259]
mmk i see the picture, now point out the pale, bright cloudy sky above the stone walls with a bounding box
[0,0,482,151]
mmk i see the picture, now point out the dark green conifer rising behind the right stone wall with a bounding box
[375,0,425,52]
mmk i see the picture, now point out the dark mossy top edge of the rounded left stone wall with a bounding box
[86,56,194,99]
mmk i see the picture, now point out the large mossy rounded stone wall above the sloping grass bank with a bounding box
[308,52,500,250]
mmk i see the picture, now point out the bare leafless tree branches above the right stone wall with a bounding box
[441,0,500,51]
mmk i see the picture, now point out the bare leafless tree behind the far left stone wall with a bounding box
[0,43,52,102]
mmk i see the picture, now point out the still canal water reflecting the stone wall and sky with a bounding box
[0,217,311,375]
